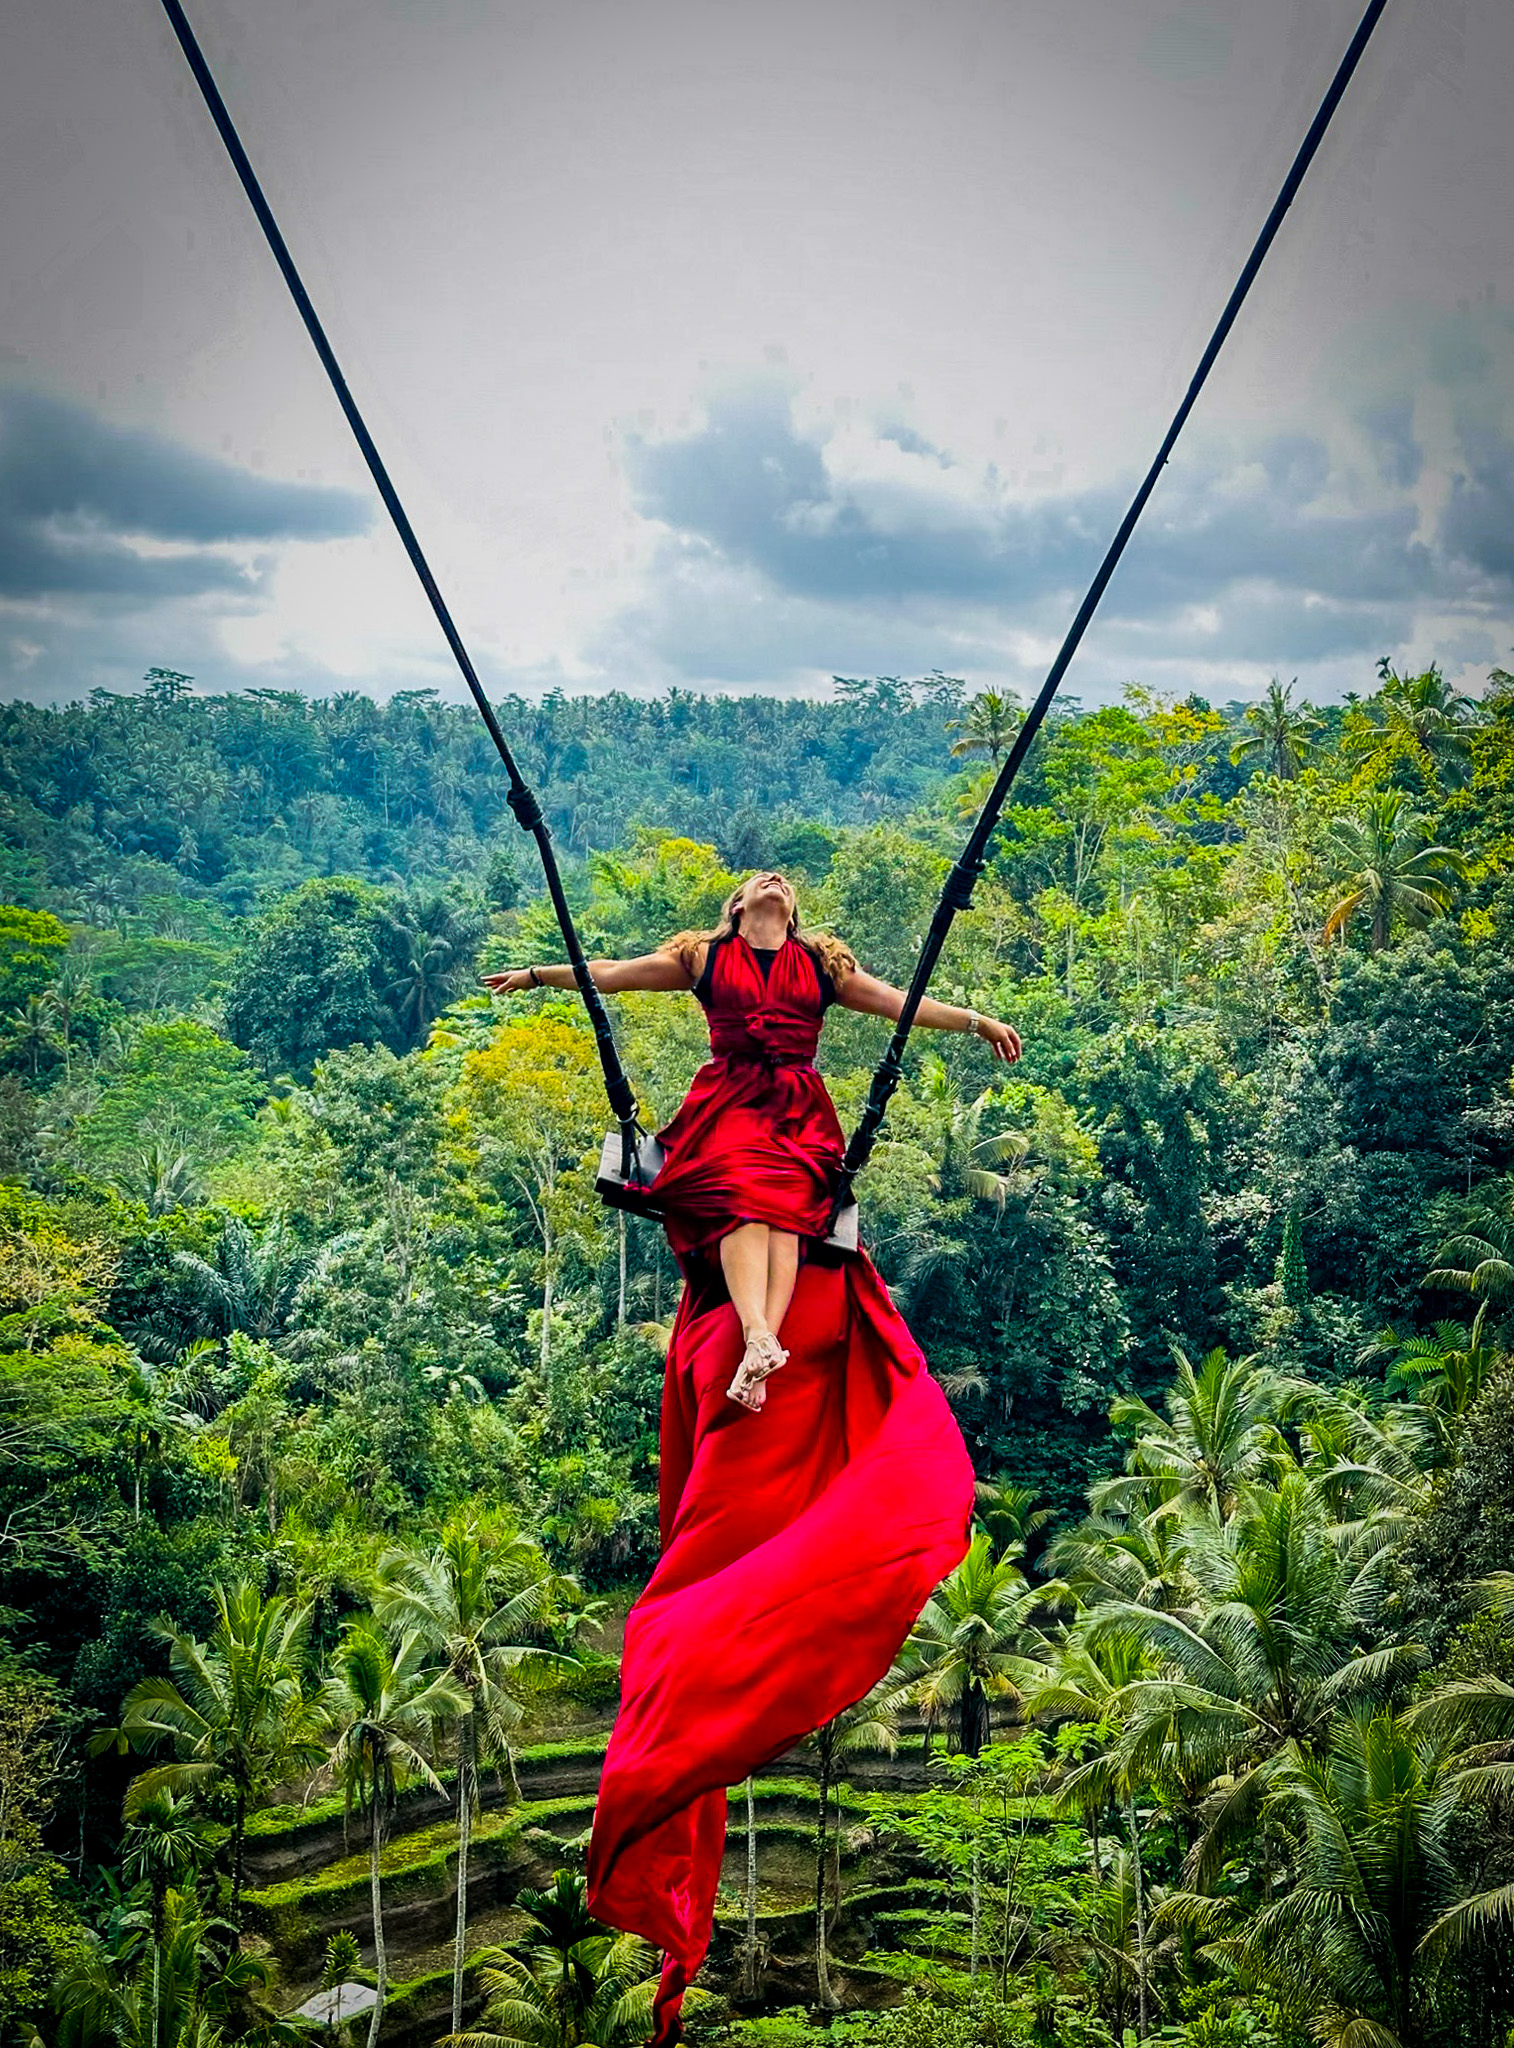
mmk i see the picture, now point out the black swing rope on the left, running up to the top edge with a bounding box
[162,0,639,1180]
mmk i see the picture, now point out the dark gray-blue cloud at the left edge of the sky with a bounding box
[0,387,369,604]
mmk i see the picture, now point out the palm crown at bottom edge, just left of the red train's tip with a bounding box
[445,1870,658,2048]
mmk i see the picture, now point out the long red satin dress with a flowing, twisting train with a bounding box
[588,934,973,2048]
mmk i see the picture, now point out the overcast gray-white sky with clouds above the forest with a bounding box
[0,0,1514,702]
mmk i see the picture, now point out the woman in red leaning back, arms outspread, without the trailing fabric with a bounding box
[488,872,1020,1411]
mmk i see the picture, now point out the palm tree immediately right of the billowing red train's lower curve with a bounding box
[903,1530,1067,1757]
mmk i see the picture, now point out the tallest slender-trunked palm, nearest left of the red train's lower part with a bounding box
[373,1513,576,2034]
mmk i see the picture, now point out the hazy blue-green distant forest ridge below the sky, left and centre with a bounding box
[0,670,1020,924]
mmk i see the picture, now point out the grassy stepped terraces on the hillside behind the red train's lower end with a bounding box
[246,1714,1036,2048]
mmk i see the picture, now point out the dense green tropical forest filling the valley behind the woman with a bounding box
[0,664,1514,2048]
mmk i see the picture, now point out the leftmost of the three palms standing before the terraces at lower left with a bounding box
[106,1581,324,1921]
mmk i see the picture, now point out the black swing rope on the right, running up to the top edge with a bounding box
[832,0,1387,1225]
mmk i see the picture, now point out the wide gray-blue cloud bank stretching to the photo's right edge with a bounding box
[621,379,1514,700]
